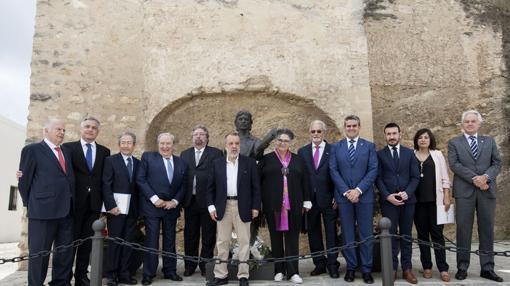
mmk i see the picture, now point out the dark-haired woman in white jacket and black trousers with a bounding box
[414,128,450,282]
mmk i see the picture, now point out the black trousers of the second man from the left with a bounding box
[73,206,99,279]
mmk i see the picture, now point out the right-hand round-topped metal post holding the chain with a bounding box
[379,217,394,286]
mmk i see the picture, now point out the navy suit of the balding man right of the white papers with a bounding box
[136,152,188,278]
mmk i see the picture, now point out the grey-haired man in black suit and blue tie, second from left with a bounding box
[64,116,110,286]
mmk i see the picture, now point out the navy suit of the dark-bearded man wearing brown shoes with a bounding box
[376,145,420,271]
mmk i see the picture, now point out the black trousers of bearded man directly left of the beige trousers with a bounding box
[184,196,216,271]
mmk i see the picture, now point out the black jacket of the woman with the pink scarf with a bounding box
[259,152,313,230]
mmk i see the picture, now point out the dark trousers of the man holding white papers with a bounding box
[105,214,137,279]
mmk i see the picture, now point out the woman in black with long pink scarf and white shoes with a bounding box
[259,129,312,284]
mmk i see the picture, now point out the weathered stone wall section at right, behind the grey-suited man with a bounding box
[364,0,510,238]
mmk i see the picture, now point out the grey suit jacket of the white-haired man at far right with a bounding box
[448,135,501,198]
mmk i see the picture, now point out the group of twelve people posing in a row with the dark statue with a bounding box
[18,110,503,286]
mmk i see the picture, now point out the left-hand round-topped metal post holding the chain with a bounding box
[90,219,105,286]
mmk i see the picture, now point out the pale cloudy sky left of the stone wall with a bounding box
[0,0,36,126]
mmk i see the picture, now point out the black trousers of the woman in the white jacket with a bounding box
[414,202,449,272]
